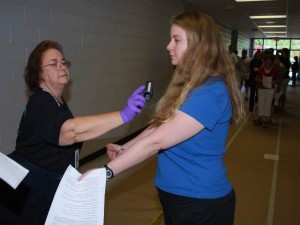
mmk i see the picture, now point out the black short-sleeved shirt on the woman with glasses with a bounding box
[15,89,82,174]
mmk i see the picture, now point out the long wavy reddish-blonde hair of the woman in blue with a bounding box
[150,11,245,127]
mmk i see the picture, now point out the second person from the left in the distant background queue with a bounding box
[237,49,251,101]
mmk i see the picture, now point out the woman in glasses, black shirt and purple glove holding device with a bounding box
[0,40,145,225]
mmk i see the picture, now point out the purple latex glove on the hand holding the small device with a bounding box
[121,85,146,123]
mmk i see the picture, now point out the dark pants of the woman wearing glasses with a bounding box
[0,154,61,225]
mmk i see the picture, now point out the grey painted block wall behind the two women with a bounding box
[0,0,184,155]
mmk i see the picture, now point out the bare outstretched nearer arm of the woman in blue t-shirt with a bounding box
[80,111,204,179]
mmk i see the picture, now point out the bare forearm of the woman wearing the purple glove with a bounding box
[59,111,124,145]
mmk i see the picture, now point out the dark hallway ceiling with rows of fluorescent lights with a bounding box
[186,0,300,38]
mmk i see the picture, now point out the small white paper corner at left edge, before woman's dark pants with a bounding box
[0,152,29,189]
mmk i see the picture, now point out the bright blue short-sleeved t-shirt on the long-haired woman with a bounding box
[155,77,232,198]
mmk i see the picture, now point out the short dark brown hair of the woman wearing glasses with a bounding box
[24,40,63,92]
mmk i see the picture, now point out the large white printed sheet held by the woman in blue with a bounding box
[45,166,106,225]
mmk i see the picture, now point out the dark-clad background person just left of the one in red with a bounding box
[249,50,262,112]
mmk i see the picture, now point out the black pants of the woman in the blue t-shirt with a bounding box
[158,189,236,225]
